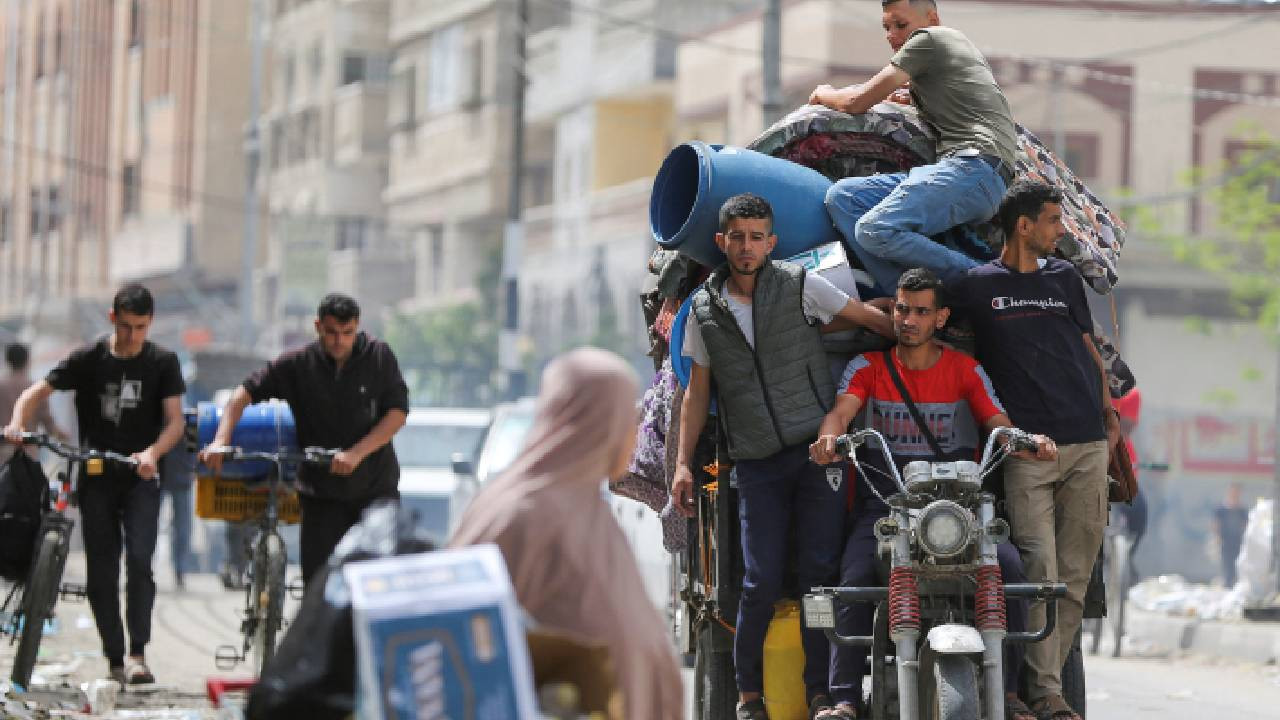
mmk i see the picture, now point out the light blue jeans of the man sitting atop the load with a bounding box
[827,156,1006,296]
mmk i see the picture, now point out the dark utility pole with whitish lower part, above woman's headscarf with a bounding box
[498,0,529,400]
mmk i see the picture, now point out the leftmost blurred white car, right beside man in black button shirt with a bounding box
[392,407,492,546]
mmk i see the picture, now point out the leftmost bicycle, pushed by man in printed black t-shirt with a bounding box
[0,433,138,688]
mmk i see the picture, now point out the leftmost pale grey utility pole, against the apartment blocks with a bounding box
[239,0,262,352]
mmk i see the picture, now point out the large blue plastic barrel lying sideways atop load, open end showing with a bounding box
[649,141,841,268]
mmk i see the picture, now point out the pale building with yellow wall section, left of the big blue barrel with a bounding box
[520,0,751,368]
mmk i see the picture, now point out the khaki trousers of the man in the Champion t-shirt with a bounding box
[1005,441,1107,701]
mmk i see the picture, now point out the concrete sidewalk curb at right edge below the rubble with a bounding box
[1125,607,1280,664]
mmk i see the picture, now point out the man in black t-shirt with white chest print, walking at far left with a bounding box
[4,283,186,684]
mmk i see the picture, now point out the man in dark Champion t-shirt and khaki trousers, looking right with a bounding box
[954,179,1120,720]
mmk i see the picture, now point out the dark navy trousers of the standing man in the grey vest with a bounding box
[733,445,845,698]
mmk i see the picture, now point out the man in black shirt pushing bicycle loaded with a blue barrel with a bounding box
[200,293,408,584]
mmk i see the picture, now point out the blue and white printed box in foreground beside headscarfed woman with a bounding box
[343,544,536,720]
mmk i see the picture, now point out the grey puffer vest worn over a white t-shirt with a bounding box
[692,260,836,460]
